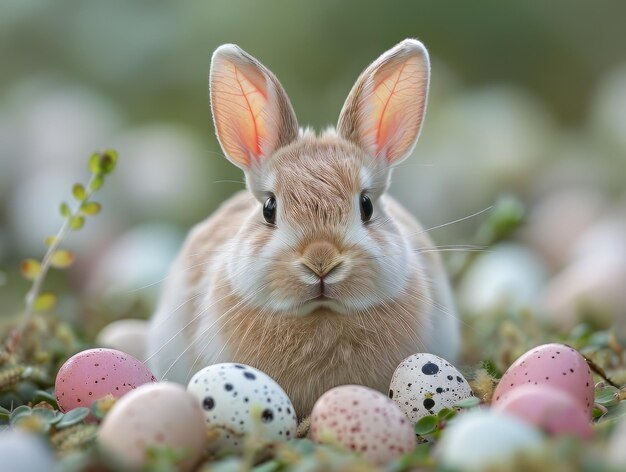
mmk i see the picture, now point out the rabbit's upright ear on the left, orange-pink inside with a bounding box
[209,44,299,170]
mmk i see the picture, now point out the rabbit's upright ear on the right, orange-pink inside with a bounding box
[337,39,430,164]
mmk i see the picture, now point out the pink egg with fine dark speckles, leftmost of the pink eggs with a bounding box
[54,349,156,411]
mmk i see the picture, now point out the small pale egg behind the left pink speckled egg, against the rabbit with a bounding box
[96,319,148,359]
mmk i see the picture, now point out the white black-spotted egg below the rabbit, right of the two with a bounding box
[389,353,474,423]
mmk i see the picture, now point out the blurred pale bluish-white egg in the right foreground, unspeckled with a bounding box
[436,410,543,472]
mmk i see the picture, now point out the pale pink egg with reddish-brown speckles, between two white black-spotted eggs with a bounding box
[311,385,416,465]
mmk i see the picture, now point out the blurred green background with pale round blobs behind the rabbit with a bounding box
[0,0,626,346]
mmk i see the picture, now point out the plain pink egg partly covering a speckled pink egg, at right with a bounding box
[493,384,593,439]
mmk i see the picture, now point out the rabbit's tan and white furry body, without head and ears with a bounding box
[149,192,459,415]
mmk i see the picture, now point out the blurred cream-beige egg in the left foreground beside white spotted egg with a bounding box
[98,382,207,470]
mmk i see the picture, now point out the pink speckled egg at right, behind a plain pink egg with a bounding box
[493,343,594,418]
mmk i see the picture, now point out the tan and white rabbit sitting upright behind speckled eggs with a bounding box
[148,39,459,418]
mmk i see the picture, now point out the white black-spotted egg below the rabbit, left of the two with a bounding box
[187,363,298,452]
